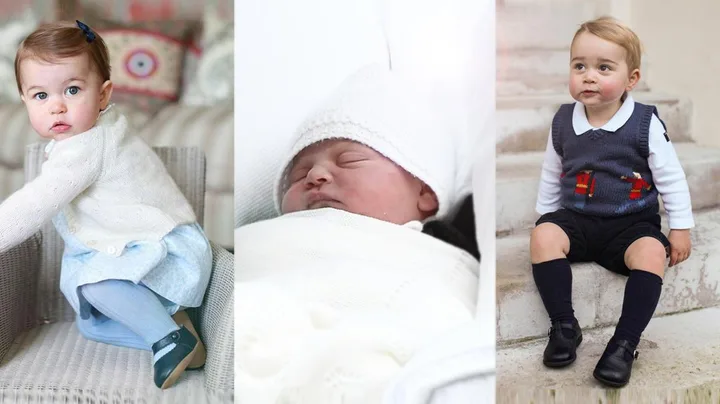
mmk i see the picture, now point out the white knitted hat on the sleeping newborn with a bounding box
[274,65,457,217]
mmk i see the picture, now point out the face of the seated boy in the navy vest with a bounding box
[570,32,640,108]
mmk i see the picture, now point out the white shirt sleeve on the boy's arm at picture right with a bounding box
[648,115,695,229]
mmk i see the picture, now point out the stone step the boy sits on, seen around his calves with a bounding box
[496,208,720,342]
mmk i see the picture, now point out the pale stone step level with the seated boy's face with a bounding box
[496,48,649,97]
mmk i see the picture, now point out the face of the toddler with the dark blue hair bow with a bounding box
[20,55,112,140]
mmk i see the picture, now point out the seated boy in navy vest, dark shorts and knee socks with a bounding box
[530,17,694,387]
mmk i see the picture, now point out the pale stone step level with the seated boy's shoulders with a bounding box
[495,91,692,153]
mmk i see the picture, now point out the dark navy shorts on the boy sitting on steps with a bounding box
[535,209,670,276]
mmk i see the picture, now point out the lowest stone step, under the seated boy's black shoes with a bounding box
[497,307,720,404]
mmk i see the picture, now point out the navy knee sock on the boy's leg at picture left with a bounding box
[533,258,575,322]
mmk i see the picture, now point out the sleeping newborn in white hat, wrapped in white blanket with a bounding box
[235,64,478,404]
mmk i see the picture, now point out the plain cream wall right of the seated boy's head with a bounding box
[630,0,720,147]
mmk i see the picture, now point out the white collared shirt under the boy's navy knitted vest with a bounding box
[535,94,695,229]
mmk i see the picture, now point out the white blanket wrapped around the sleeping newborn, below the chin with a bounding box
[235,209,478,404]
